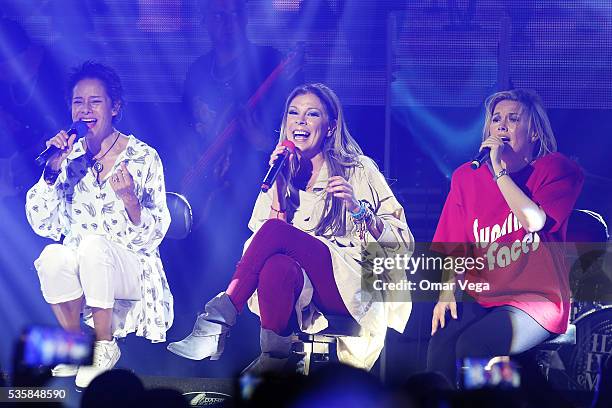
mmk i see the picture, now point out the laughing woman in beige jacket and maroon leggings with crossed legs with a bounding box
[168,84,413,374]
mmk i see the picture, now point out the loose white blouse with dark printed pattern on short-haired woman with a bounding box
[26,135,174,342]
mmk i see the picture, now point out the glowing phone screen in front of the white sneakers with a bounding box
[21,326,94,367]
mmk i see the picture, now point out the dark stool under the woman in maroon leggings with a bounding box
[293,315,362,375]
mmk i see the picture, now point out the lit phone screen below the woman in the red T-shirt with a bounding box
[461,357,521,389]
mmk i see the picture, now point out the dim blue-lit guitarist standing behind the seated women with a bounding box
[165,0,299,350]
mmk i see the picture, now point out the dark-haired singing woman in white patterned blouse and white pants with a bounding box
[26,62,173,387]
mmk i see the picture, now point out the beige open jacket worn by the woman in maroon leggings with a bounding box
[245,156,414,370]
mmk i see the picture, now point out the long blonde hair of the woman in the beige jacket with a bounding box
[280,83,363,236]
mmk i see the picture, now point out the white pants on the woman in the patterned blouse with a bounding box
[34,235,142,309]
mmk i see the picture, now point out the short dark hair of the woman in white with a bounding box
[66,61,125,117]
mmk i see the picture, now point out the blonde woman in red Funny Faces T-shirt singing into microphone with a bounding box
[427,89,583,383]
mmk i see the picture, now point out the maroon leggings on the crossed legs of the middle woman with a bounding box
[226,219,350,335]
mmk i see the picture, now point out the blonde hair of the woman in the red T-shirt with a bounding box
[482,89,557,159]
